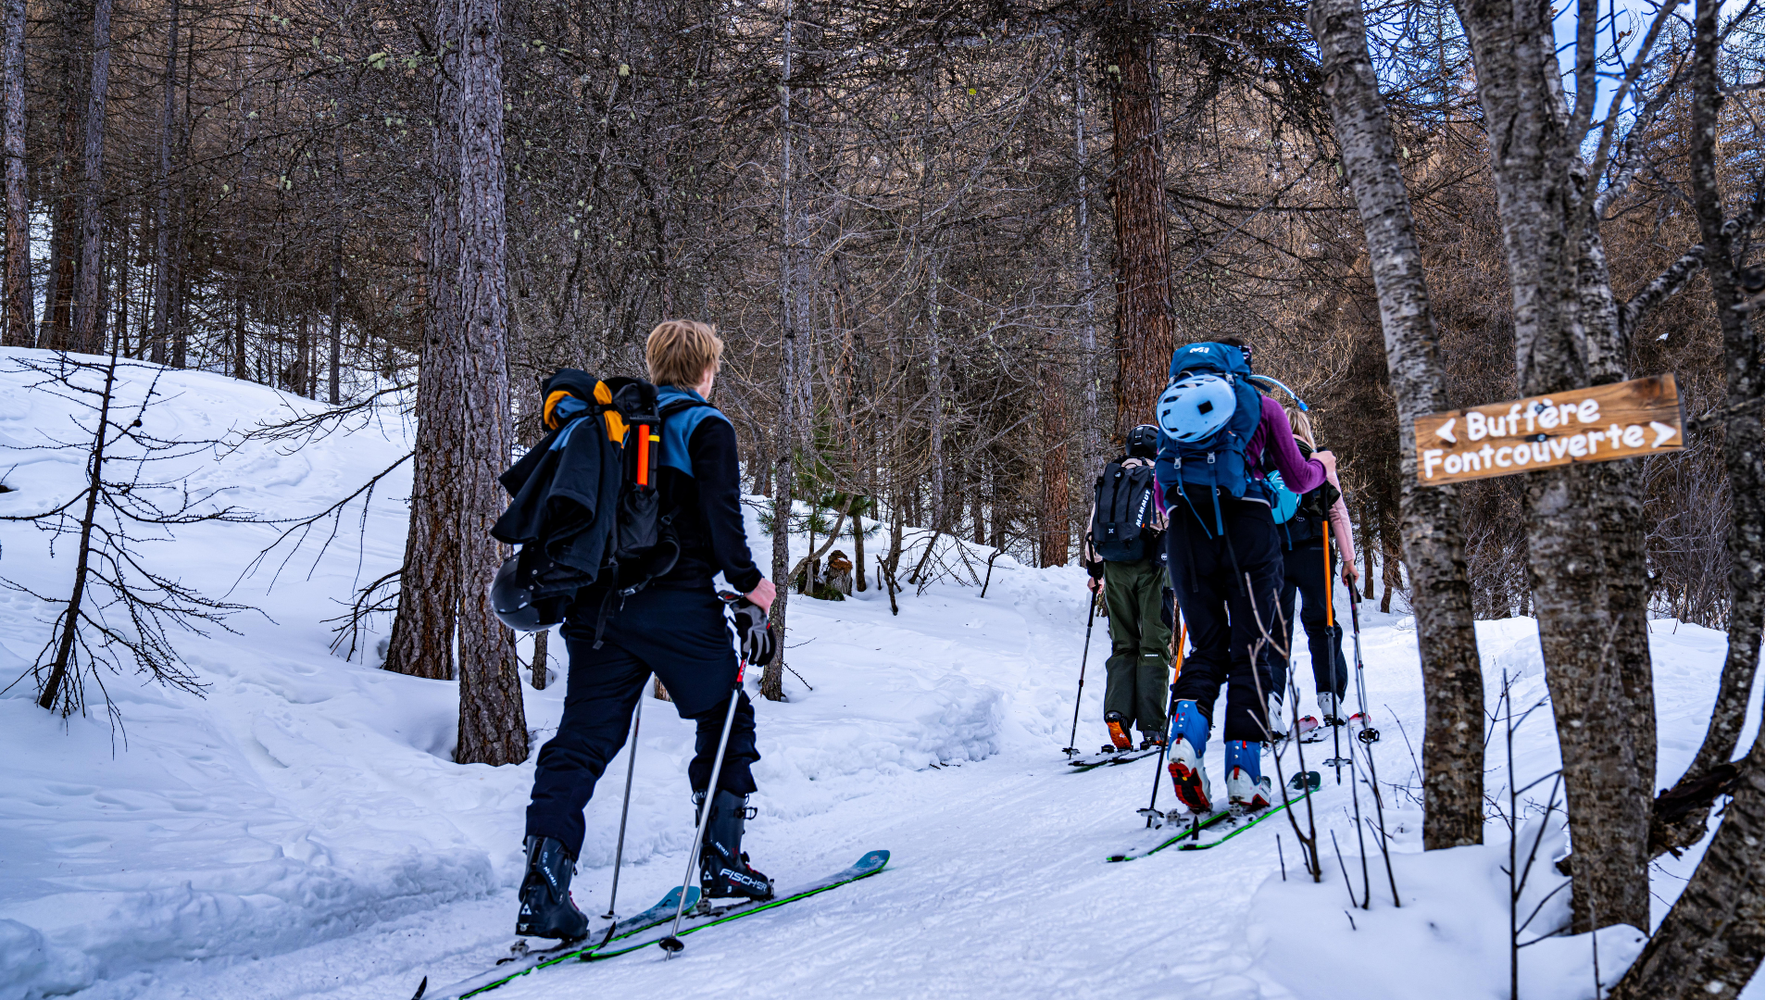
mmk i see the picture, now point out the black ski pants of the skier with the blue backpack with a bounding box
[1166,500,1282,740]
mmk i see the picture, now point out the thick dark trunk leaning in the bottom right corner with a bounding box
[1611,724,1766,1000]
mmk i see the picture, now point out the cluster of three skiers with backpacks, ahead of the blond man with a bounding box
[1083,338,1355,811]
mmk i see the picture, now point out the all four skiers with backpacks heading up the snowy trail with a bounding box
[489,320,1353,941]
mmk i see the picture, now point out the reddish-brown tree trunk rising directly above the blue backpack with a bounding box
[1104,4,1173,431]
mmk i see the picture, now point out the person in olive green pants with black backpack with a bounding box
[1085,423,1173,749]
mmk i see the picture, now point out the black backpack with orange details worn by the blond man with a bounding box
[489,368,693,632]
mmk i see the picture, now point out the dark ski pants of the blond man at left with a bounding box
[525,589,759,858]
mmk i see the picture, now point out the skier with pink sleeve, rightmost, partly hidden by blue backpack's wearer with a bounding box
[1266,406,1357,733]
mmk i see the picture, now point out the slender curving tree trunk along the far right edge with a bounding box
[1682,0,1766,800]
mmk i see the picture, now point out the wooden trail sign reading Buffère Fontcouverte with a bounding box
[1414,374,1686,486]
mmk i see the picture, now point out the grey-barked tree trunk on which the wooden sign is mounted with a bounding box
[1458,0,1655,932]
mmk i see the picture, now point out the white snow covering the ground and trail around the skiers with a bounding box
[0,351,1764,1000]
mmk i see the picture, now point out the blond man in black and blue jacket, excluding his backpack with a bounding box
[519,320,777,940]
